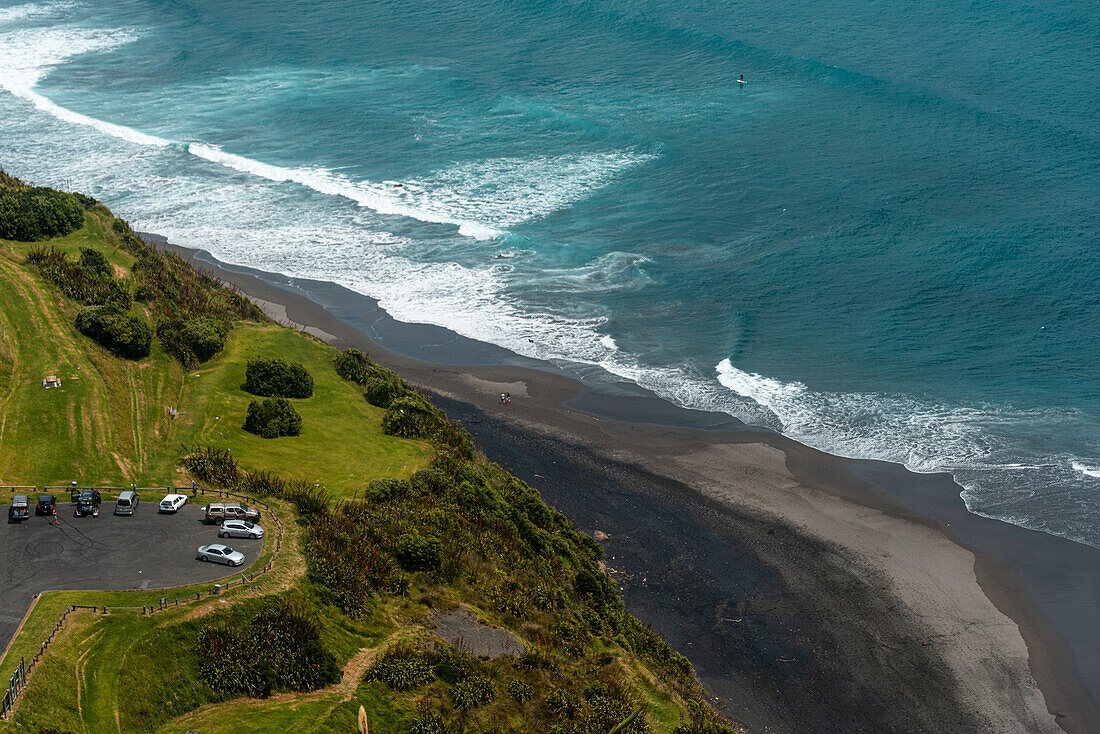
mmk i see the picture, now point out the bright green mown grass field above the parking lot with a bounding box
[0,215,431,496]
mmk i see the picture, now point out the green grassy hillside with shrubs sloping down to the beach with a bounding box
[0,174,734,734]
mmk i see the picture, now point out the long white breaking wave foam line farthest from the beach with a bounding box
[0,3,653,240]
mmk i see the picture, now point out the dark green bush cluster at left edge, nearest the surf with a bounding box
[0,171,88,242]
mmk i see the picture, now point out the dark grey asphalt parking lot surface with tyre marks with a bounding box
[0,495,266,650]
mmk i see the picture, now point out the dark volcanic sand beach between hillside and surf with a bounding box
[159,240,1100,734]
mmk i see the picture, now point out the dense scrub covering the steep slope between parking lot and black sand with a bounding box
[178,352,733,734]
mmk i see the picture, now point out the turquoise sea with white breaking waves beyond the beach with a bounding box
[0,0,1100,545]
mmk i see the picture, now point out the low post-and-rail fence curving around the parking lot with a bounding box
[0,484,284,720]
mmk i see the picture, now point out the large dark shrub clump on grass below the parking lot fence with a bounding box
[198,598,340,697]
